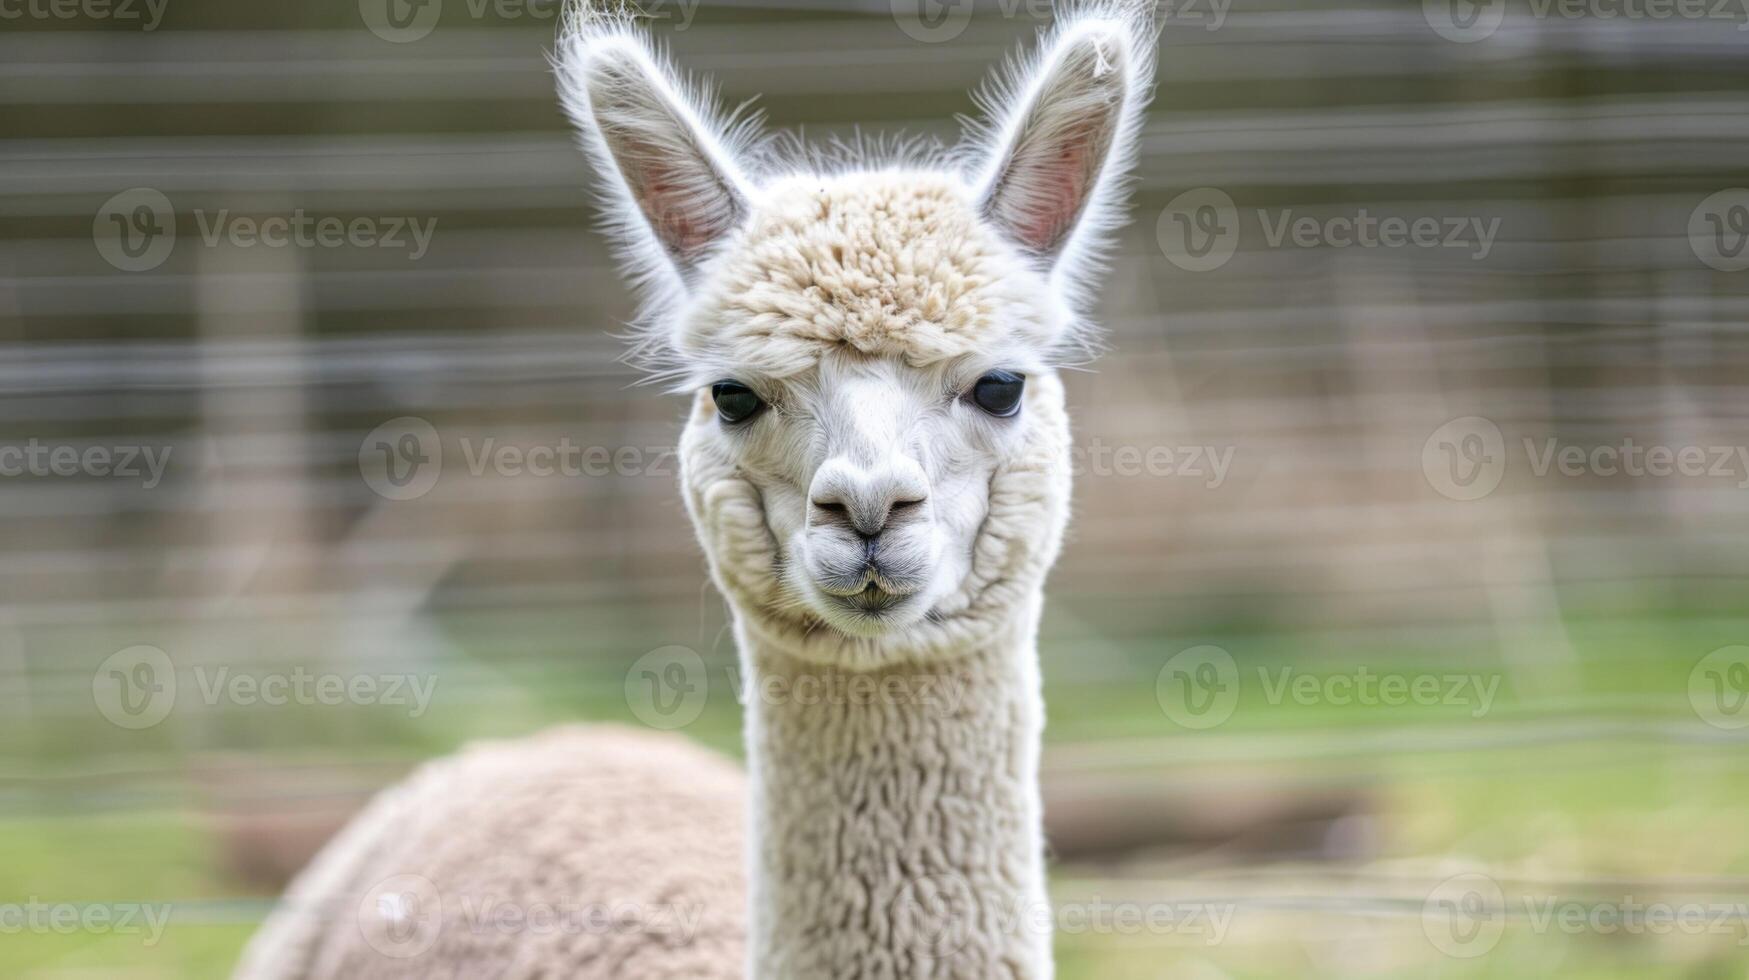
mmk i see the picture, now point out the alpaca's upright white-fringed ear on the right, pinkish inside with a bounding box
[983,19,1151,261]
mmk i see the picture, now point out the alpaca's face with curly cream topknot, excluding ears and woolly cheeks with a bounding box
[677,173,1067,637]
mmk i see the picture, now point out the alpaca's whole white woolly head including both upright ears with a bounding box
[558,4,1154,667]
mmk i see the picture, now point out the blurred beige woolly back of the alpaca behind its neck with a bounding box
[236,726,747,980]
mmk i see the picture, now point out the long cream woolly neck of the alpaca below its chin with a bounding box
[738,597,1051,980]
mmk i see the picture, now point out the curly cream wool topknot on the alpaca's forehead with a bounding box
[677,172,1067,378]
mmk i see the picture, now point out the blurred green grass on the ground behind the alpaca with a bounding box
[0,616,1749,980]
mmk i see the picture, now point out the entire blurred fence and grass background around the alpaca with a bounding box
[0,0,1749,980]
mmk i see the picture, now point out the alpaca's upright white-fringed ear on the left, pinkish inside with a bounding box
[558,30,747,278]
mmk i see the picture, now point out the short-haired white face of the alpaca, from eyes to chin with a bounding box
[687,339,1060,637]
